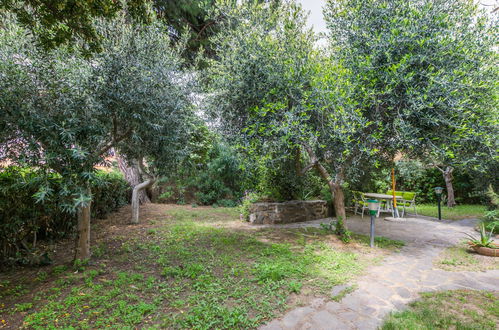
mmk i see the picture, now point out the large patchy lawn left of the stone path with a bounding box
[0,204,402,329]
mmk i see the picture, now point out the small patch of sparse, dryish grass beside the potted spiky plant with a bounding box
[433,242,499,272]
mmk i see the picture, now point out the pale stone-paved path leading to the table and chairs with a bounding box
[261,217,499,330]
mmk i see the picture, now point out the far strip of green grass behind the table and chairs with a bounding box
[414,204,487,220]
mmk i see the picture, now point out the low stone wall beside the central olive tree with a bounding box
[249,200,328,224]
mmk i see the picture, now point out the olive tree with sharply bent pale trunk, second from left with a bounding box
[92,21,194,223]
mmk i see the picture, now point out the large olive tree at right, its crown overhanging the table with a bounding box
[325,0,498,205]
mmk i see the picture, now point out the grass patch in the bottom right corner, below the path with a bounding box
[382,290,499,330]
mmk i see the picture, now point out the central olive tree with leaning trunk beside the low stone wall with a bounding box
[203,3,371,234]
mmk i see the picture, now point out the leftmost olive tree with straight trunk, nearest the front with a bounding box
[0,18,195,259]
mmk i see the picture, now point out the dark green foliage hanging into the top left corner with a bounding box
[0,0,152,52]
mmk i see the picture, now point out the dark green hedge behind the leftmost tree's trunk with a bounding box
[0,166,130,261]
